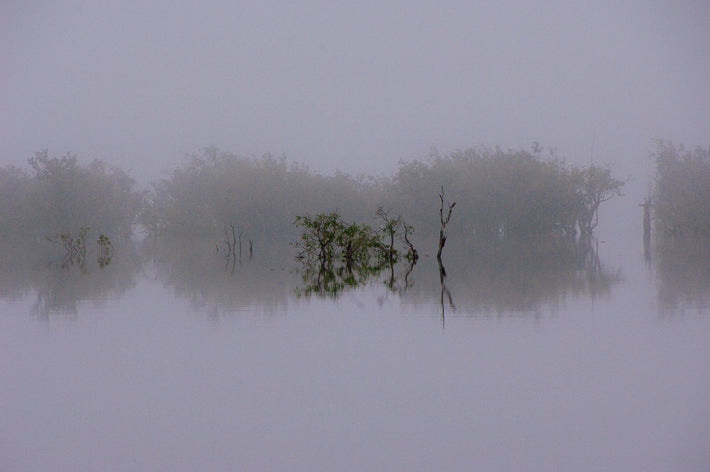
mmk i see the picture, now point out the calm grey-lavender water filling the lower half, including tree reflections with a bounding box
[0,233,710,471]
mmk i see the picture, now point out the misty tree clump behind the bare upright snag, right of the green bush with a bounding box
[386,145,623,239]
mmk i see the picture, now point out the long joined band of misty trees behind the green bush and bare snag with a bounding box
[141,146,623,242]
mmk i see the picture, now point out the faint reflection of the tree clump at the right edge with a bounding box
[654,238,710,313]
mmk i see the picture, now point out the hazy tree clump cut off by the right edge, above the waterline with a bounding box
[652,141,710,237]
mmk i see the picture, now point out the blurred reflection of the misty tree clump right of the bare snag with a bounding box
[404,238,622,314]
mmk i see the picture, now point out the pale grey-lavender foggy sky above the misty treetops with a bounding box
[0,0,710,188]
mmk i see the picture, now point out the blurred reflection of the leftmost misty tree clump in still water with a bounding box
[0,238,141,317]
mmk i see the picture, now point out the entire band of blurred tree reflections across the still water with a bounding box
[5,232,710,320]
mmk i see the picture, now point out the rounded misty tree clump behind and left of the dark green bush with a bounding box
[141,148,379,239]
